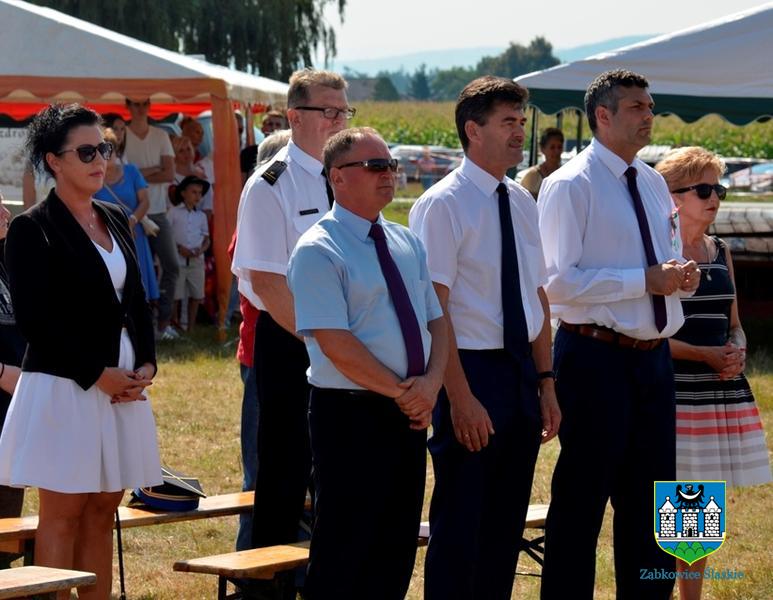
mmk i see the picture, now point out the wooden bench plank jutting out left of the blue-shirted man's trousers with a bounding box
[173,541,309,579]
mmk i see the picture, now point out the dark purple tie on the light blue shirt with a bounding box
[368,223,424,377]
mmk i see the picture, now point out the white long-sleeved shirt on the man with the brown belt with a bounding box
[539,139,684,340]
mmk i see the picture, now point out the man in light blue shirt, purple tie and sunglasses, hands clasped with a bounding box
[288,128,447,600]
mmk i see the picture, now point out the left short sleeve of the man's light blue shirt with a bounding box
[287,243,349,336]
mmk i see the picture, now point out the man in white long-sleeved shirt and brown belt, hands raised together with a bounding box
[539,71,700,600]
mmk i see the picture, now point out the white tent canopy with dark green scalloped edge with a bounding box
[516,2,773,125]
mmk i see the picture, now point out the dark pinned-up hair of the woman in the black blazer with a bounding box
[25,104,102,177]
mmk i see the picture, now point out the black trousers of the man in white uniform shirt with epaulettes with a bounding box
[252,312,311,548]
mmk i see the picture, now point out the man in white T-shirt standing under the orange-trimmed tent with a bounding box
[123,98,179,340]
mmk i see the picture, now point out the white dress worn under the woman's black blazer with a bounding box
[0,234,162,493]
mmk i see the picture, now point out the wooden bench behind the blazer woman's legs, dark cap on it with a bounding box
[0,492,255,564]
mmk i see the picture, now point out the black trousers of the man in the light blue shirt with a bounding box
[304,388,427,600]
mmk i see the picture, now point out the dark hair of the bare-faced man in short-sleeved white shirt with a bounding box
[456,75,529,151]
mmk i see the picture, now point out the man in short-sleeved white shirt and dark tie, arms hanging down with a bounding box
[409,77,561,600]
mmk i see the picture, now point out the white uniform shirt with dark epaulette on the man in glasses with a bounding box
[231,141,330,310]
